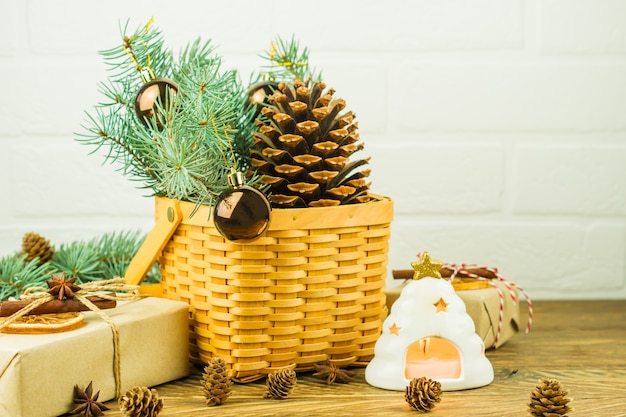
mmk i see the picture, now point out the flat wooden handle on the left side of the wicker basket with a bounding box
[124,199,183,285]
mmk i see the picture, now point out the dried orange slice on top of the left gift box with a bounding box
[0,312,85,334]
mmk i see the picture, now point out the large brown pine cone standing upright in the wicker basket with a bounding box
[250,79,370,207]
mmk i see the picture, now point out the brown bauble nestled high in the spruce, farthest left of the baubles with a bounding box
[135,77,178,130]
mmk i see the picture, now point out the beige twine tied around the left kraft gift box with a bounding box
[0,278,139,398]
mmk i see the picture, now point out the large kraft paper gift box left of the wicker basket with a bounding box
[0,297,189,417]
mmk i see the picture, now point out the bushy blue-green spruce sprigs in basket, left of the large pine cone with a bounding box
[77,22,258,205]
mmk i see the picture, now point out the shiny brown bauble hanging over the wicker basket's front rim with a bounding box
[213,170,271,242]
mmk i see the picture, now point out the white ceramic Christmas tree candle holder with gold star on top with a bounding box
[365,252,493,391]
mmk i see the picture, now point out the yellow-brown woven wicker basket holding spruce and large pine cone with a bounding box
[126,197,393,382]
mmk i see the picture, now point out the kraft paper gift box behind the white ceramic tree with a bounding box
[386,280,520,348]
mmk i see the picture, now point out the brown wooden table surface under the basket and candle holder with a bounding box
[105,300,626,417]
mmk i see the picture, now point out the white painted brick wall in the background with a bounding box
[0,0,626,299]
